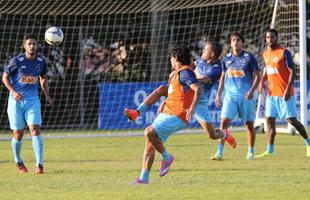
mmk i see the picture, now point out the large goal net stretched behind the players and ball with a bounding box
[0,0,298,134]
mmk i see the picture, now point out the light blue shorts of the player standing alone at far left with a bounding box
[7,95,42,130]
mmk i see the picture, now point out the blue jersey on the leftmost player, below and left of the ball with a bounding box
[5,54,47,99]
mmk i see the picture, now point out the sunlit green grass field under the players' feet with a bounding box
[0,133,310,200]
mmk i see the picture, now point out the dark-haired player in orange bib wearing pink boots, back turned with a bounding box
[133,46,202,184]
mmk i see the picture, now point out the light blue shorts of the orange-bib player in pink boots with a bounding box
[152,113,186,142]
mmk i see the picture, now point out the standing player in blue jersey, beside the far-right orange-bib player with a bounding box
[211,32,260,160]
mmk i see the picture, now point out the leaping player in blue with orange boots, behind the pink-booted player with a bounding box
[124,42,236,182]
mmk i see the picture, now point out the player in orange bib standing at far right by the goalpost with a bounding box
[256,29,310,157]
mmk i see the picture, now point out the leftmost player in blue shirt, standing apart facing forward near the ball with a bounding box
[2,33,53,174]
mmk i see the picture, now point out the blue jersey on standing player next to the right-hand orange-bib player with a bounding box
[222,51,259,97]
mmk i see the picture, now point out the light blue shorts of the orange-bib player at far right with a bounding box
[265,96,297,119]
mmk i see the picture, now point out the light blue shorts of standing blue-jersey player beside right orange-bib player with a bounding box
[221,93,255,122]
